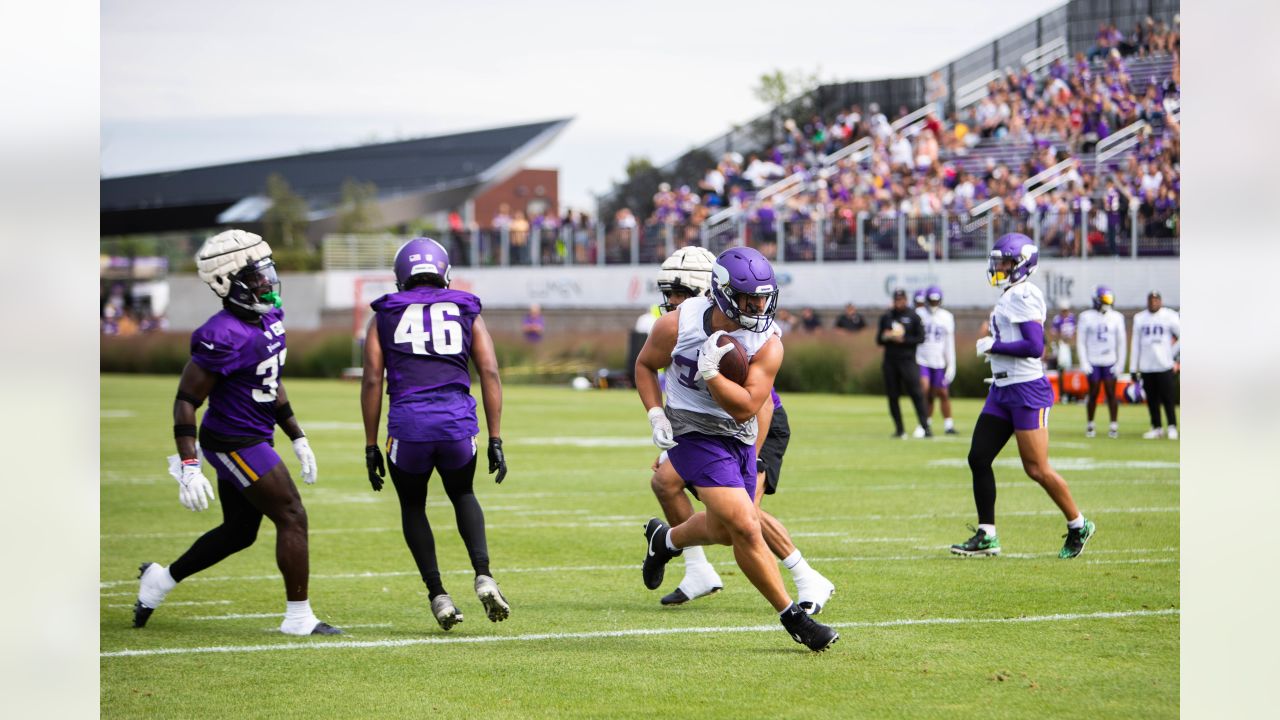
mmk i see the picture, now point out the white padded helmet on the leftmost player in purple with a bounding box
[196,229,280,315]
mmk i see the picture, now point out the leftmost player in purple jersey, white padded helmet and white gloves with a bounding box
[133,229,342,635]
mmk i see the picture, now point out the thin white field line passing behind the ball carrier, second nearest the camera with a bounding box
[99,506,1181,539]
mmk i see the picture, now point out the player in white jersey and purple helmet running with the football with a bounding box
[635,247,840,651]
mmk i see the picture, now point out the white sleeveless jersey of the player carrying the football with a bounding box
[667,297,780,445]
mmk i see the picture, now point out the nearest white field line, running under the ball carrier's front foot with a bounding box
[99,609,1181,657]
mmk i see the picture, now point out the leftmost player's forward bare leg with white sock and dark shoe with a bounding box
[244,462,338,635]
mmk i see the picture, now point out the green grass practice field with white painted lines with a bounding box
[100,375,1179,719]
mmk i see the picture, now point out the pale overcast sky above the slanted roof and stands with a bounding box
[101,0,1064,210]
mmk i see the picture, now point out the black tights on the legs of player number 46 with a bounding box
[389,457,489,598]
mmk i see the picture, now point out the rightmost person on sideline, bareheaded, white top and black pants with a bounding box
[1129,290,1183,439]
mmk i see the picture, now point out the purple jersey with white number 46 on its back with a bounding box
[371,286,480,442]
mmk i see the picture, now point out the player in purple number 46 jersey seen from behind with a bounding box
[360,237,511,630]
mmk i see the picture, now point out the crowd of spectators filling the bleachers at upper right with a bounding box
[620,18,1180,255]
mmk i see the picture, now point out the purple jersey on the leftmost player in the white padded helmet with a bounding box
[191,310,285,442]
